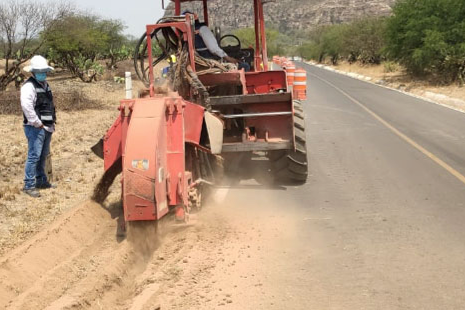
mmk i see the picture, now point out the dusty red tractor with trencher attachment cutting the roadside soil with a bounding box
[92,0,307,226]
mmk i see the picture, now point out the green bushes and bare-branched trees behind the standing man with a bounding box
[0,0,134,91]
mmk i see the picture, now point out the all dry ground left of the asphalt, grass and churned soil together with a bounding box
[0,66,292,309]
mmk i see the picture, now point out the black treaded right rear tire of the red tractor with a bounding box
[268,101,308,185]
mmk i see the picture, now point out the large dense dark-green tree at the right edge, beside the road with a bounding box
[386,0,465,84]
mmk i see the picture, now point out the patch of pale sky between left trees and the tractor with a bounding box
[36,0,170,37]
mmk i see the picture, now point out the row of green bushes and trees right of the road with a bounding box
[296,0,465,85]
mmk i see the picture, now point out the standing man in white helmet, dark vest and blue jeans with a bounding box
[21,55,56,198]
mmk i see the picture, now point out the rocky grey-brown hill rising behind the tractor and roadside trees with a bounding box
[166,0,395,31]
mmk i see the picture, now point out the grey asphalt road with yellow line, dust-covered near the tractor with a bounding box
[217,65,465,309]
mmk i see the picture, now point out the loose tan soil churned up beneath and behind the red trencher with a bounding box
[0,183,293,310]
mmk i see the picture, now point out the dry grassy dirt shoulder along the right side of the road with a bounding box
[312,62,465,112]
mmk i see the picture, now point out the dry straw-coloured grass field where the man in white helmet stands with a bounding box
[0,71,142,254]
